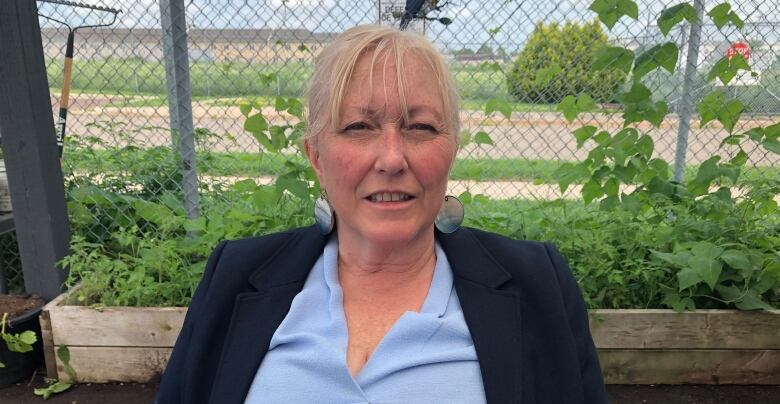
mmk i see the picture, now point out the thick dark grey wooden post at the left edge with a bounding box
[0,0,70,300]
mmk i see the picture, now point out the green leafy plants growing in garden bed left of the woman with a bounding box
[62,180,314,306]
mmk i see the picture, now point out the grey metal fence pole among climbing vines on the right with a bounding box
[674,0,704,182]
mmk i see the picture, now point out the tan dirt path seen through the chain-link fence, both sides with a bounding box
[56,94,780,166]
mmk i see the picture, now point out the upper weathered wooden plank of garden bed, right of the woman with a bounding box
[590,310,780,349]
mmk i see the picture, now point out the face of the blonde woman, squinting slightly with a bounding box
[306,50,456,245]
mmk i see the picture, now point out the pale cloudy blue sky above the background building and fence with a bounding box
[39,0,780,52]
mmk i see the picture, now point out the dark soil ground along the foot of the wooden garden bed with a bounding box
[0,370,780,404]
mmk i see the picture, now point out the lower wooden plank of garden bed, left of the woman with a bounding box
[57,346,172,383]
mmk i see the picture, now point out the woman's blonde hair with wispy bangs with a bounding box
[304,25,460,147]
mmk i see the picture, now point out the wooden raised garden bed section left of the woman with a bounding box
[40,294,187,383]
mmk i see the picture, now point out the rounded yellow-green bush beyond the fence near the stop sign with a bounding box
[506,21,626,104]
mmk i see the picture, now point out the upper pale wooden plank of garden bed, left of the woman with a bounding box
[49,306,187,347]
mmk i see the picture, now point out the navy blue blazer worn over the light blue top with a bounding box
[157,227,607,404]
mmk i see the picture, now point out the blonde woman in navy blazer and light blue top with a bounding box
[158,26,606,403]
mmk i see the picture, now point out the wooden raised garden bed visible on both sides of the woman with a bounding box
[41,288,780,384]
